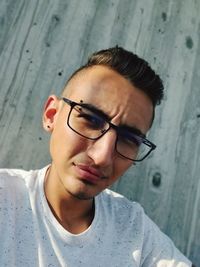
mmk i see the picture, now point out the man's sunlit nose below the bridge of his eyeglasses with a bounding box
[87,129,117,167]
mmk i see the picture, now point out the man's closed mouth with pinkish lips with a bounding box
[74,163,105,184]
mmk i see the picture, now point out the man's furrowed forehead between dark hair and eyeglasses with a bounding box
[64,66,153,133]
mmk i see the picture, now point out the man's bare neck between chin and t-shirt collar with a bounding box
[44,167,94,234]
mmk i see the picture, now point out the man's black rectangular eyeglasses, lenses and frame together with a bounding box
[62,97,156,162]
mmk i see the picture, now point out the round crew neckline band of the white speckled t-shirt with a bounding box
[38,168,100,245]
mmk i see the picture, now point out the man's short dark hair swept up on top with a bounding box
[68,46,164,107]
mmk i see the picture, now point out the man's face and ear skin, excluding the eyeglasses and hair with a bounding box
[45,66,153,199]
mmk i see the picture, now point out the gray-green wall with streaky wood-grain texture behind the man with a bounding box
[0,0,200,266]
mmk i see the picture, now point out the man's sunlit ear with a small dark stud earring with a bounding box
[42,95,60,132]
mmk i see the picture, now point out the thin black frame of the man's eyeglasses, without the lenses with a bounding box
[62,97,156,162]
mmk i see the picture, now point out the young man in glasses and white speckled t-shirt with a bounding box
[0,47,191,267]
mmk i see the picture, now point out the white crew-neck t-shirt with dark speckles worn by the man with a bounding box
[0,167,191,267]
